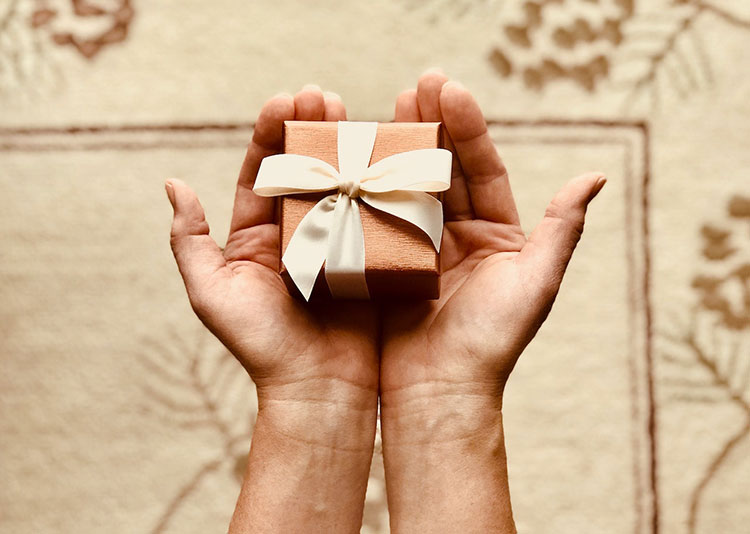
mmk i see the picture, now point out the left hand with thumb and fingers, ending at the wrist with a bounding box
[166,86,378,418]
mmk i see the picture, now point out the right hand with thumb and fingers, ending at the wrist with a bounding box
[380,73,599,398]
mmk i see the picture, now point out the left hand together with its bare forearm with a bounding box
[166,86,379,532]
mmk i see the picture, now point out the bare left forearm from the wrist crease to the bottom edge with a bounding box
[229,383,377,534]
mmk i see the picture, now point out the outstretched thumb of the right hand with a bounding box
[518,173,607,297]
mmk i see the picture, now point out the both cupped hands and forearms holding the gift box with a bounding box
[167,71,604,534]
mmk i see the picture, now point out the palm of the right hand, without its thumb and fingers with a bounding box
[381,198,532,390]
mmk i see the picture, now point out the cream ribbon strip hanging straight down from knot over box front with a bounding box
[325,194,370,299]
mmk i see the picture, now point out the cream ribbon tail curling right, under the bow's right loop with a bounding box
[360,191,443,252]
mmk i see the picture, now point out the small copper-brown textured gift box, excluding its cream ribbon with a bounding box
[278,121,443,299]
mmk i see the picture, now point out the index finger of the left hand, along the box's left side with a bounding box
[230,94,294,232]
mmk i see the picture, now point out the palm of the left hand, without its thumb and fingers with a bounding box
[222,224,377,384]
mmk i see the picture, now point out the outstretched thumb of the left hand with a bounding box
[166,180,226,311]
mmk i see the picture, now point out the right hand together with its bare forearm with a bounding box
[380,71,604,532]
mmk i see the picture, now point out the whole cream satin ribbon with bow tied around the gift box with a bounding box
[253,121,452,300]
